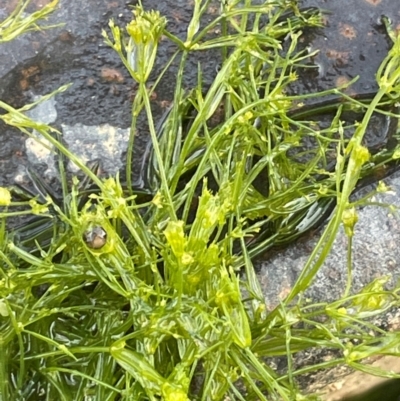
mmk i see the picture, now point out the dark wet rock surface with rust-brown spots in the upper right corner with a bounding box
[297,0,400,95]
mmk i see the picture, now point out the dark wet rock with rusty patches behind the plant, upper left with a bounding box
[0,0,222,182]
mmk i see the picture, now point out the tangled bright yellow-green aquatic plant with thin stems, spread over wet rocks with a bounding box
[0,0,400,401]
